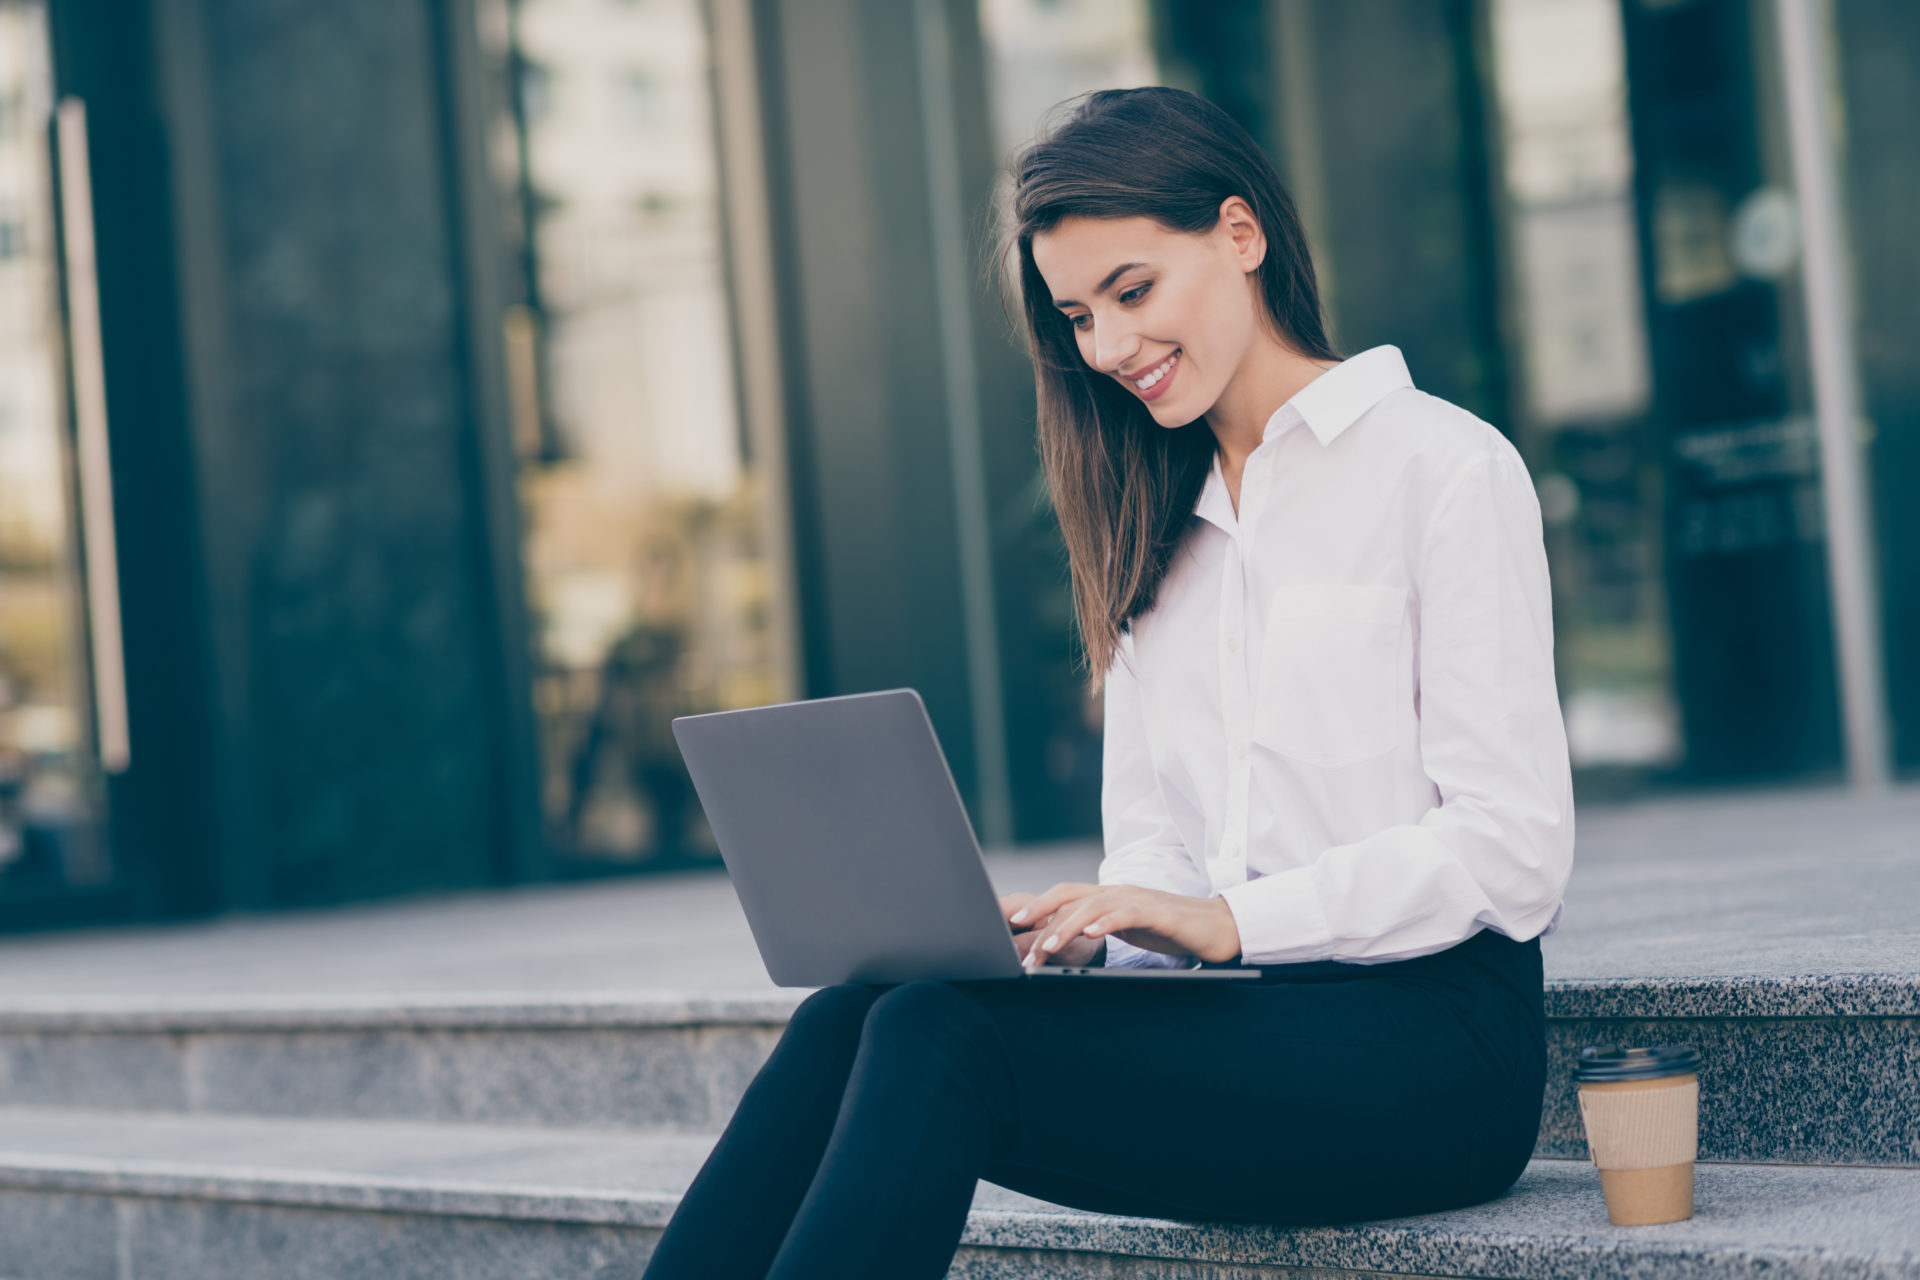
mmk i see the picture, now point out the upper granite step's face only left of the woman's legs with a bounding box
[0,990,806,1134]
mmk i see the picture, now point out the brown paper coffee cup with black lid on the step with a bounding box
[1574,1044,1699,1226]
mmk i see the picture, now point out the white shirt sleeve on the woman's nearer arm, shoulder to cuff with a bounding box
[1221,439,1572,965]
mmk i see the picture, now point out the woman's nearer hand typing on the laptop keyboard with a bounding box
[1000,883,1240,965]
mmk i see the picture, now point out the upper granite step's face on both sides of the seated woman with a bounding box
[0,977,1920,1167]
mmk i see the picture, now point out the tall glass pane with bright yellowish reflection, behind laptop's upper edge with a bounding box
[478,0,793,864]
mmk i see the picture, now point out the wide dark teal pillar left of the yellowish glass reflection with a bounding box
[144,0,534,908]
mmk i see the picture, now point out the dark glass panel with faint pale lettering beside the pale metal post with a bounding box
[1624,0,1841,781]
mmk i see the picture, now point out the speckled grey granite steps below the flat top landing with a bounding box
[0,977,1920,1280]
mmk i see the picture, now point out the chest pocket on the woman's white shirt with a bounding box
[1252,585,1407,768]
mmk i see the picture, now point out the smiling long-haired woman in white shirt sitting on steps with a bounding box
[647,88,1572,1280]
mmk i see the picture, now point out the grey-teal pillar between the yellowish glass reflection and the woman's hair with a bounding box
[755,0,987,818]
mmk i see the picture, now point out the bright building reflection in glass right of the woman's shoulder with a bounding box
[1490,0,1674,766]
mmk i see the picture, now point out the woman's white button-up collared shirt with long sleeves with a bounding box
[1098,345,1572,967]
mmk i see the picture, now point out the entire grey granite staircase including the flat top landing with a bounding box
[0,791,1920,1280]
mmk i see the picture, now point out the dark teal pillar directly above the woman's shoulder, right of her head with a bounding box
[1229,0,1513,434]
